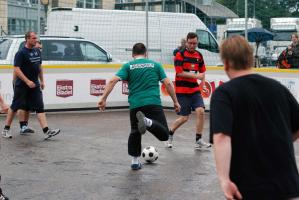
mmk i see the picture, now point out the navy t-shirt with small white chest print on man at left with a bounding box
[14,47,42,86]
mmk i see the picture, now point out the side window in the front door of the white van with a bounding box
[197,30,219,53]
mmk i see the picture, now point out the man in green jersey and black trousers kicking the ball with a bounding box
[98,43,181,170]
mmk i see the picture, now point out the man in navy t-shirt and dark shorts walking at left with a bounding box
[2,31,60,139]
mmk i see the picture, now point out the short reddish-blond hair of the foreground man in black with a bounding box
[220,36,253,70]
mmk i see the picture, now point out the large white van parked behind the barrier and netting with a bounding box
[46,8,221,66]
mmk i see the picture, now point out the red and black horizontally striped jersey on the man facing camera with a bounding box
[174,49,206,94]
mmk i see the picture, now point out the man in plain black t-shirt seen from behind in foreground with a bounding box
[210,36,299,200]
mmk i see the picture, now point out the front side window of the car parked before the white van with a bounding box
[80,42,108,62]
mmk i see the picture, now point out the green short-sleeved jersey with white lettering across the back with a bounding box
[116,58,166,109]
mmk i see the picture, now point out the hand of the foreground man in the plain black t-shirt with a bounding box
[220,180,243,200]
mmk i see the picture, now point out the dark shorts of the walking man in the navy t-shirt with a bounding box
[10,85,44,113]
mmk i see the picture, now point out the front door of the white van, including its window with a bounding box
[196,30,222,66]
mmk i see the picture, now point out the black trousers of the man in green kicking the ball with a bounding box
[128,105,169,157]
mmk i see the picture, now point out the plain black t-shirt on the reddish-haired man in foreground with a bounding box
[210,74,299,200]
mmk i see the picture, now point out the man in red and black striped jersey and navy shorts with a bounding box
[166,32,211,149]
